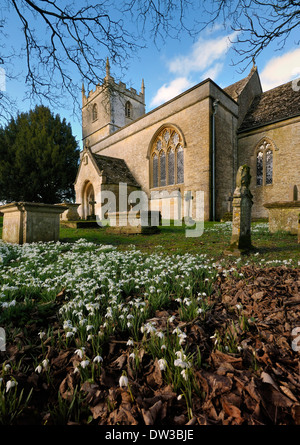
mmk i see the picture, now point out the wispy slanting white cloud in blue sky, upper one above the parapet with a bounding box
[169,32,236,76]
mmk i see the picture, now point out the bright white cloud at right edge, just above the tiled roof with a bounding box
[260,49,300,91]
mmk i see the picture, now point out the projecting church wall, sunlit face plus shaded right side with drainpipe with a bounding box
[78,80,238,220]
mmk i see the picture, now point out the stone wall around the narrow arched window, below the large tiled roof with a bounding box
[238,118,300,218]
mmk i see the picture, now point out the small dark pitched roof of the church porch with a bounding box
[92,153,140,187]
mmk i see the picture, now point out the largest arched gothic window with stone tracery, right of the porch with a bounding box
[150,128,184,188]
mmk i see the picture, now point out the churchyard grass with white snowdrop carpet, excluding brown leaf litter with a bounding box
[0,218,299,423]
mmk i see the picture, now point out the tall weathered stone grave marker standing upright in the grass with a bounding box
[230,165,253,250]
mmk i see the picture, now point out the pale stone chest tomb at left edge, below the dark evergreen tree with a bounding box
[0,202,68,244]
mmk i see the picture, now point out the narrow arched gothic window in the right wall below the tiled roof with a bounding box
[256,140,273,186]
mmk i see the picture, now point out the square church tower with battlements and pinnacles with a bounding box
[82,58,145,147]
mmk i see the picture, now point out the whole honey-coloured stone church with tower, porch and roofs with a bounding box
[74,57,300,220]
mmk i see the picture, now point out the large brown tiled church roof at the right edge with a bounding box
[239,82,300,132]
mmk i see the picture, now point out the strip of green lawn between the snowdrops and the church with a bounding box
[60,222,300,262]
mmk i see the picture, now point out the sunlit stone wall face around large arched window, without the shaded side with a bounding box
[92,82,216,219]
